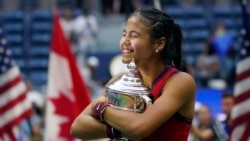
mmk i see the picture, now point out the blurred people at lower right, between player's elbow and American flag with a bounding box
[189,91,234,141]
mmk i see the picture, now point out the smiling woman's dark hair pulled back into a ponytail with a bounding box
[130,7,182,69]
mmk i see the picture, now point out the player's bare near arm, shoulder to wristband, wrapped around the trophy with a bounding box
[104,73,195,140]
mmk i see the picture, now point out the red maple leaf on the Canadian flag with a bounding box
[50,92,75,141]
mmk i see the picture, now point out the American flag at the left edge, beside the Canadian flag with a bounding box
[0,25,32,141]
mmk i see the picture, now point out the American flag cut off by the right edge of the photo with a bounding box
[229,0,250,141]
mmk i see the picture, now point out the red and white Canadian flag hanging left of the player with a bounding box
[45,11,91,141]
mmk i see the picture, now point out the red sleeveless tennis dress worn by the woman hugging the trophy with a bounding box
[141,67,192,141]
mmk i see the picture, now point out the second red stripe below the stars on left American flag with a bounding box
[0,92,26,115]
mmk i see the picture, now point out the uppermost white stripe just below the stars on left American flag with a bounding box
[0,66,20,87]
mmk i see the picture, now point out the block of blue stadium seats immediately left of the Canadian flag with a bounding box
[28,9,53,88]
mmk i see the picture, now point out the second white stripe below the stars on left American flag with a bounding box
[0,81,26,109]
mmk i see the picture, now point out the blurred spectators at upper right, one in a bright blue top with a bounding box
[193,23,236,89]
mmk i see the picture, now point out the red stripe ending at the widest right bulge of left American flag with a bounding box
[0,108,33,137]
